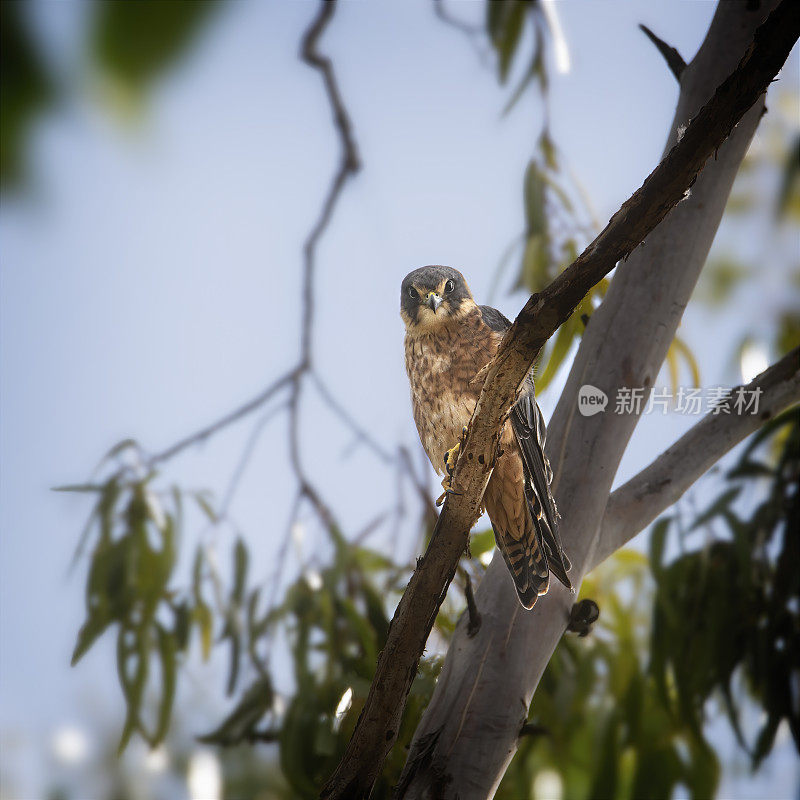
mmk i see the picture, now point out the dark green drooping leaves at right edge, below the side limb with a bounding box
[651,408,800,768]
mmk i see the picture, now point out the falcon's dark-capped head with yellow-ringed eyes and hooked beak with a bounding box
[400,266,475,331]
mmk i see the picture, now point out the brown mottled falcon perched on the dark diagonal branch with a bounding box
[400,266,572,608]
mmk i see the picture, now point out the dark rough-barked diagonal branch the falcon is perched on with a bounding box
[321,0,800,798]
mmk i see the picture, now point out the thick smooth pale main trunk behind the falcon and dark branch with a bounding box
[398,0,777,800]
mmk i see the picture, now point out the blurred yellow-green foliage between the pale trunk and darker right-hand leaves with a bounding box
[497,550,719,800]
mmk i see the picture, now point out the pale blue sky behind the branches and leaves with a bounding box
[0,0,797,796]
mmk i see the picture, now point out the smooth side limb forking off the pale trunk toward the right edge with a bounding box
[591,348,800,569]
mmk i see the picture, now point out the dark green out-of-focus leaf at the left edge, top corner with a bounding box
[0,2,54,188]
